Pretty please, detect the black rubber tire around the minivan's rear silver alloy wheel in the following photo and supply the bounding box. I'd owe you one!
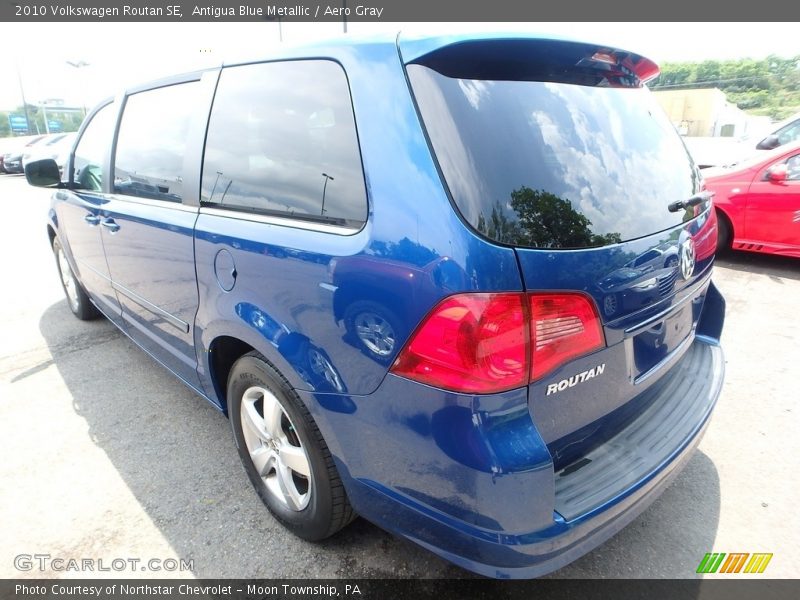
[227,352,356,542]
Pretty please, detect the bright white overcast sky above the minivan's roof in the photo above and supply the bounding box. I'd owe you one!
[0,22,800,110]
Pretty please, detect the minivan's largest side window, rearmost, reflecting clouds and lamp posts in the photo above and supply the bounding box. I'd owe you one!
[202,60,367,228]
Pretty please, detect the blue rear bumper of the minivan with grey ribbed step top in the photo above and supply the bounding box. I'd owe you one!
[302,336,724,578]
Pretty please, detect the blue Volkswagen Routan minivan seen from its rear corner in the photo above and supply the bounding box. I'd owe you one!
[26,35,725,577]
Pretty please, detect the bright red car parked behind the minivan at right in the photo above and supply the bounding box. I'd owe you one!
[704,142,800,258]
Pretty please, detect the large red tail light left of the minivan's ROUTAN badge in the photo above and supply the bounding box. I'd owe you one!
[391,293,604,394]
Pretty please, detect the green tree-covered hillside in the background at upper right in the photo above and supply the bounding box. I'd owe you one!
[650,54,800,120]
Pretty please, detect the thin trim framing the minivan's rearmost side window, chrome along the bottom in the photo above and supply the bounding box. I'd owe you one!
[197,56,371,236]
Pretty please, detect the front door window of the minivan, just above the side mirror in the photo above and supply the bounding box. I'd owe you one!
[72,103,117,192]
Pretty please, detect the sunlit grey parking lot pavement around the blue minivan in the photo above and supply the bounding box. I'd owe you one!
[0,175,800,578]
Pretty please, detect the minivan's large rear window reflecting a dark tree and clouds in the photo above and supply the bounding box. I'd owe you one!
[408,64,700,248]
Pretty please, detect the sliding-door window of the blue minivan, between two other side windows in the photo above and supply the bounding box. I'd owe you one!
[114,82,198,202]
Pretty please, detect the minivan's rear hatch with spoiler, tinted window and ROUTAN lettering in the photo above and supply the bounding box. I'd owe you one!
[401,39,716,470]
